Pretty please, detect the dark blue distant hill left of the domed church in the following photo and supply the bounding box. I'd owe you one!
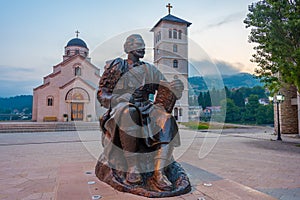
[0,95,32,113]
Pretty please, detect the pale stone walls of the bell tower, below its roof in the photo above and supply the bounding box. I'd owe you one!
[153,21,189,122]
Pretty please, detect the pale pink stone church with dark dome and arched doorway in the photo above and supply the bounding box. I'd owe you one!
[32,31,100,122]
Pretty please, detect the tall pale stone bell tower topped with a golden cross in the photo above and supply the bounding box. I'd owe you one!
[151,4,192,122]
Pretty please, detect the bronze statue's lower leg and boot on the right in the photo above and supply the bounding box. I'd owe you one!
[153,146,173,191]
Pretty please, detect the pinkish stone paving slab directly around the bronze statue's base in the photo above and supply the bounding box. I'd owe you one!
[55,163,275,200]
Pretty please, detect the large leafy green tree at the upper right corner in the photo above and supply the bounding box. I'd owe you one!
[244,0,300,93]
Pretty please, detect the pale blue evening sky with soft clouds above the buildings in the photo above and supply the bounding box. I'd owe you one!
[0,0,255,97]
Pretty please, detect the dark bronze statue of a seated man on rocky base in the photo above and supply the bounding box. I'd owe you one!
[95,34,191,197]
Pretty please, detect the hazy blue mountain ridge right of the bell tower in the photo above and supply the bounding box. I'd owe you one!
[189,73,263,92]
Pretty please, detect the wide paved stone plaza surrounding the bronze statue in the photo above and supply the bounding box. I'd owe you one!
[0,124,300,200]
